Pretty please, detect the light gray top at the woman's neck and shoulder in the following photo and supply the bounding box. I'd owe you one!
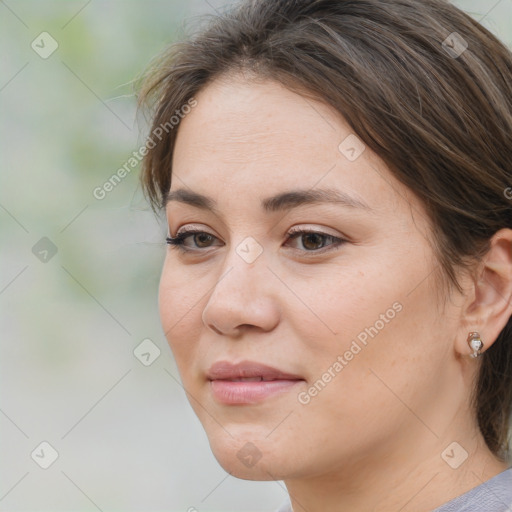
[276,467,512,512]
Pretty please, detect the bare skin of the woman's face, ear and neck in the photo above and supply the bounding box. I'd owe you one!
[159,75,512,512]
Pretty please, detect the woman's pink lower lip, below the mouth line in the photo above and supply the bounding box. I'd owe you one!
[210,380,304,405]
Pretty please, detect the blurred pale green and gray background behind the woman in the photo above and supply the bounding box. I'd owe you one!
[0,0,512,512]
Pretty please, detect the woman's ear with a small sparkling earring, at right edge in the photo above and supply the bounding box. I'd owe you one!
[457,228,512,355]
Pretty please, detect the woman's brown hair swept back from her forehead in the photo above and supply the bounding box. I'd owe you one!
[139,0,512,460]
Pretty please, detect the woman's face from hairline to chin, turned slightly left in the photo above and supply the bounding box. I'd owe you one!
[159,77,463,480]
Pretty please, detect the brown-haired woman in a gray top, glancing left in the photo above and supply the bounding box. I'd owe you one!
[140,0,512,512]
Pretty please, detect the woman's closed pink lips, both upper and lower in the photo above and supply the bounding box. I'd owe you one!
[207,361,305,405]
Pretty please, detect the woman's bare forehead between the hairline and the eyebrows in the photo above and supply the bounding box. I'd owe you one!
[171,76,413,215]
